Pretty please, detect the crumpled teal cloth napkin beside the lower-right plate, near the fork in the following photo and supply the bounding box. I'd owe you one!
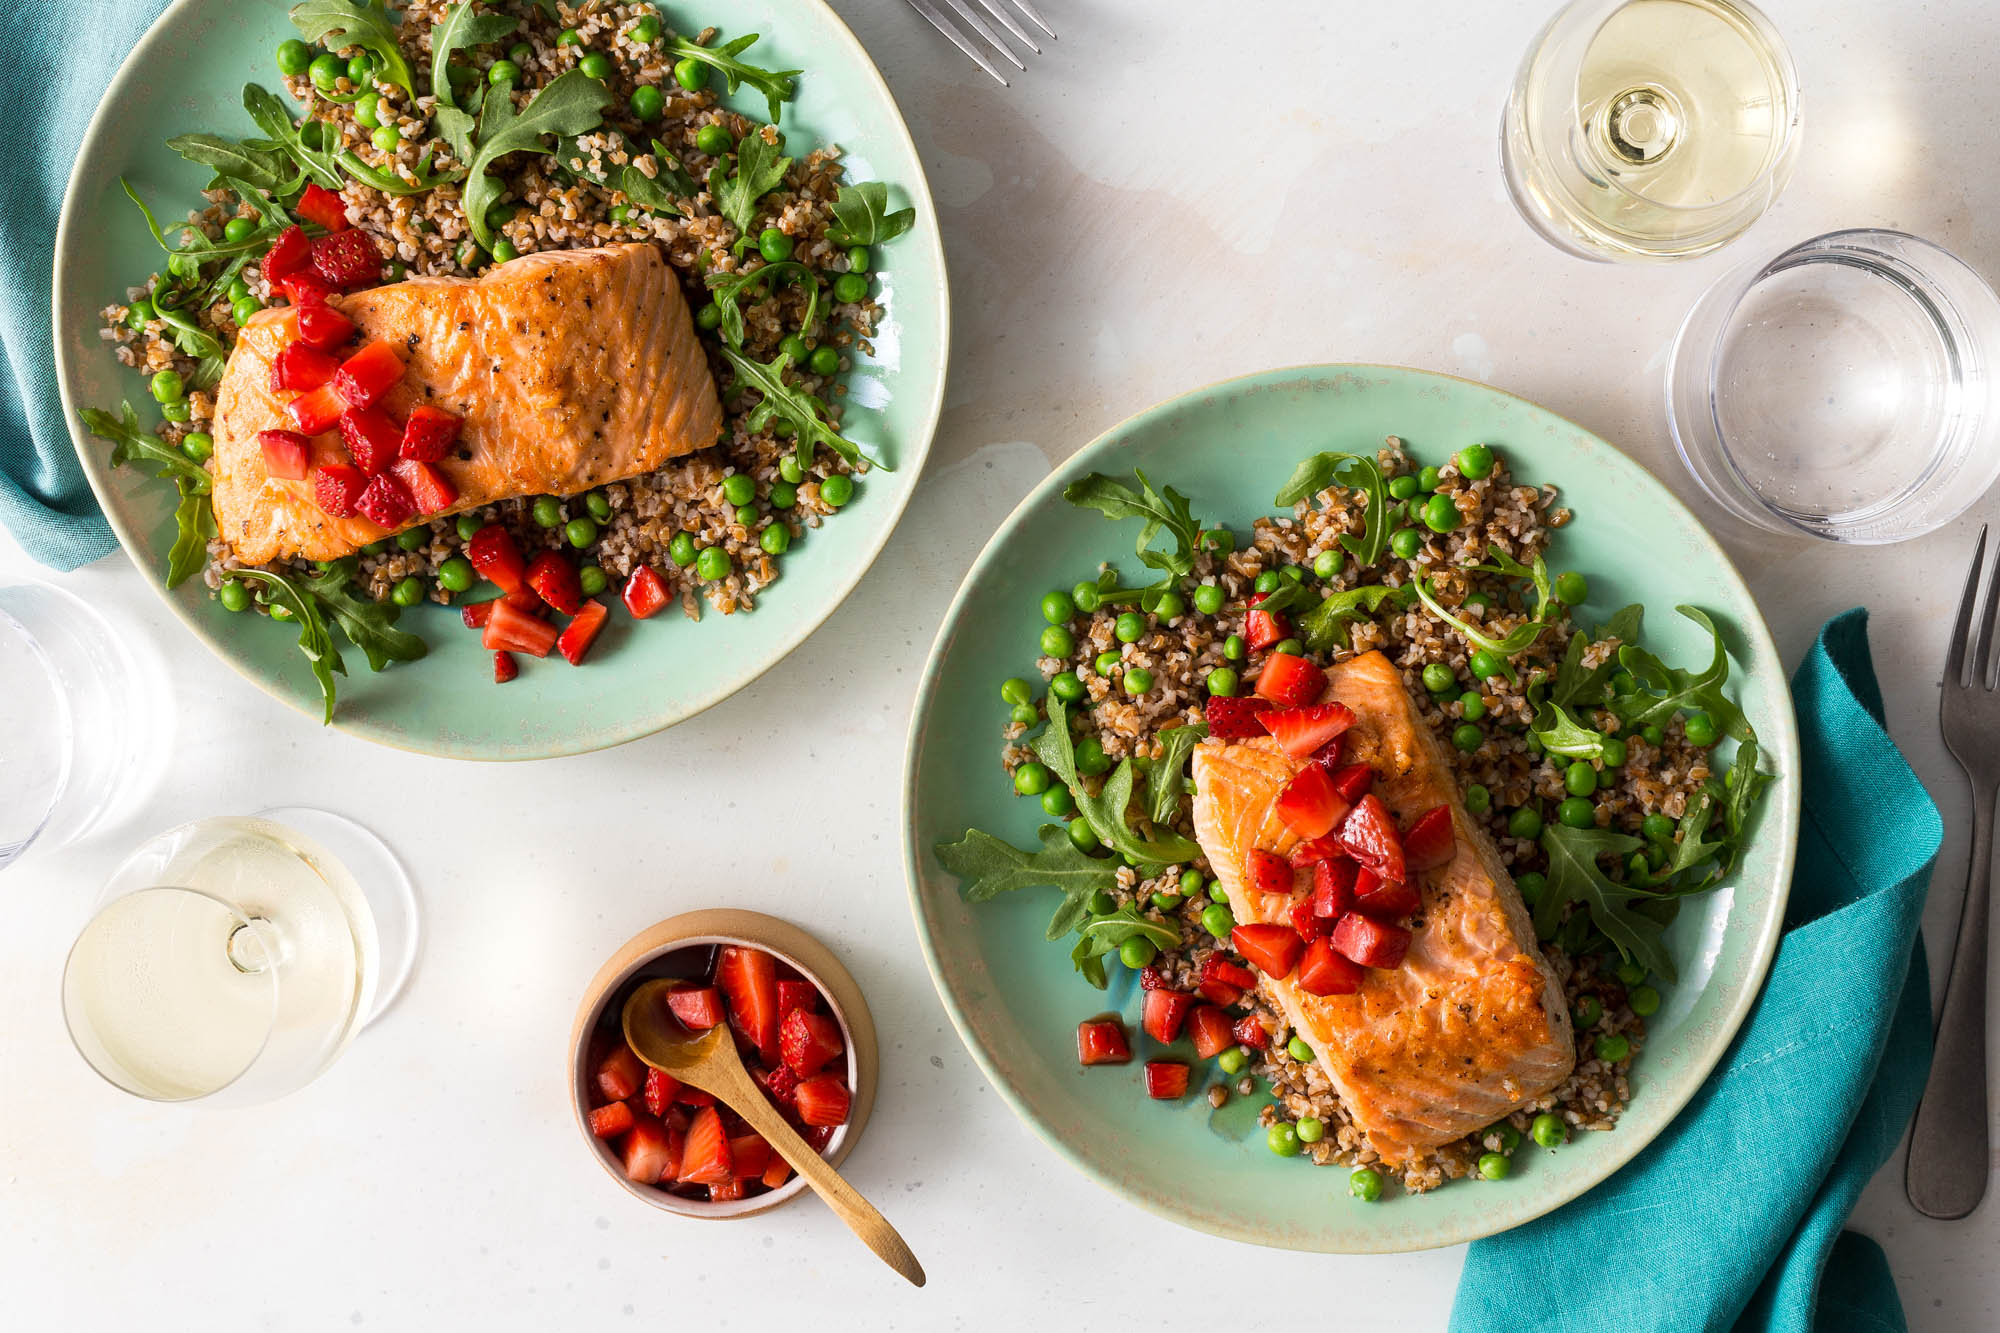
[1452,610,1942,1333]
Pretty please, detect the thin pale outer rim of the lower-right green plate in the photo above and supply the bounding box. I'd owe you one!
[902,362,1800,1255]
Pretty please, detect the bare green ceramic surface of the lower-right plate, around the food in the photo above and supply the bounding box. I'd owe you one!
[904,366,1798,1253]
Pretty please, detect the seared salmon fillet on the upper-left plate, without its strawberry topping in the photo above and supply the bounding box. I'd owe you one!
[214,244,722,564]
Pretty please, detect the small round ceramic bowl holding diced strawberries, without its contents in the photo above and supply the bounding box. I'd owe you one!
[570,909,880,1219]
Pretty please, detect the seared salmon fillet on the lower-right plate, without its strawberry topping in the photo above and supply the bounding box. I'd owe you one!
[1194,652,1576,1165]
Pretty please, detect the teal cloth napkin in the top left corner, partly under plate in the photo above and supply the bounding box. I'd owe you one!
[0,0,164,568]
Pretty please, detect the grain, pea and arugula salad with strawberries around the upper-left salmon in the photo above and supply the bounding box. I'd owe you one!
[82,0,914,719]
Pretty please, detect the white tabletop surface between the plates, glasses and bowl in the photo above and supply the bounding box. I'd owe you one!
[0,0,2000,1329]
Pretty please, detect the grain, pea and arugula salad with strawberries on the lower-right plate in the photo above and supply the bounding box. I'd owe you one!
[936,436,1770,1201]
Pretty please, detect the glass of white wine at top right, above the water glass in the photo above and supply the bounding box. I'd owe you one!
[1500,0,1800,260]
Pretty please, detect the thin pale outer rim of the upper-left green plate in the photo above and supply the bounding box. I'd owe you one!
[50,0,952,763]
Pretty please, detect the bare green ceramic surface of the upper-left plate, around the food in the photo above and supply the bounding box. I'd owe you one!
[56,0,950,759]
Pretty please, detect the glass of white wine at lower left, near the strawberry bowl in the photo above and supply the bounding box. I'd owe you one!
[62,809,416,1105]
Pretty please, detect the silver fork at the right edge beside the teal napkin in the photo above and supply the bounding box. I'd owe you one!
[1902,526,2000,1221]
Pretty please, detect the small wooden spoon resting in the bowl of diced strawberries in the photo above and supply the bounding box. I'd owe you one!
[624,979,924,1287]
